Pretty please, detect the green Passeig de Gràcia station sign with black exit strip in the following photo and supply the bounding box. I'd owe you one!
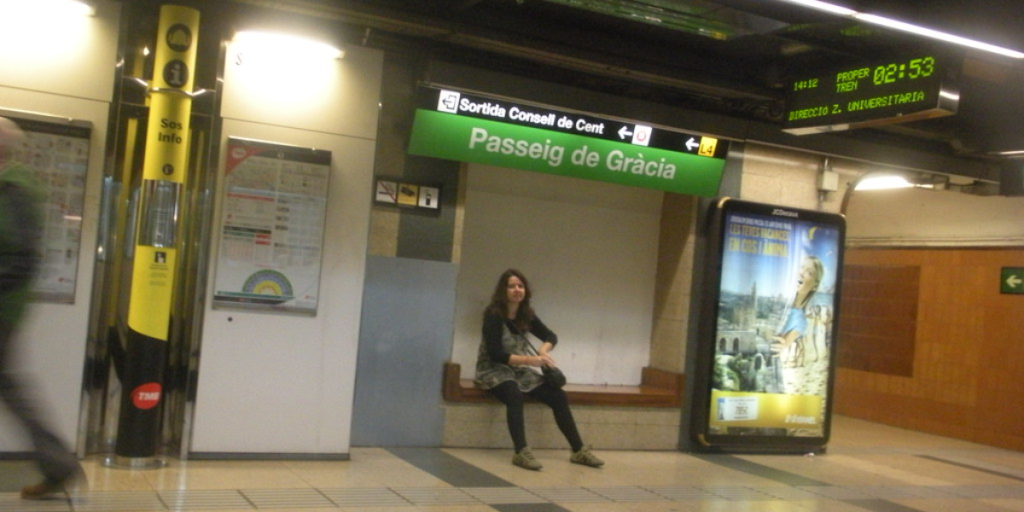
[409,89,727,197]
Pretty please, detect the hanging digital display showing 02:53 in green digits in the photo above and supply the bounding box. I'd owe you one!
[782,54,959,135]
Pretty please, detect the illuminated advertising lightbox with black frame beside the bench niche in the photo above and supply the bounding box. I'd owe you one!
[693,199,845,450]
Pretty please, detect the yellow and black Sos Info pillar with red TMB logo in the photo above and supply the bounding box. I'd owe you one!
[115,5,199,467]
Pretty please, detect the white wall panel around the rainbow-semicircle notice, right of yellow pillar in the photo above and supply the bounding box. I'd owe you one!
[190,41,383,455]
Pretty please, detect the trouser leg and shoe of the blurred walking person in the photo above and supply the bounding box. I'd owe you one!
[0,322,81,496]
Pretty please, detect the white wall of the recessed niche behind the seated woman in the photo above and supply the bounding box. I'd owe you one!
[453,164,662,385]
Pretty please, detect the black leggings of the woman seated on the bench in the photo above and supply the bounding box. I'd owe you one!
[490,381,583,454]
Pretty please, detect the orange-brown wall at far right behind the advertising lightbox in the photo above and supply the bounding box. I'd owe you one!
[834,248,1024,451]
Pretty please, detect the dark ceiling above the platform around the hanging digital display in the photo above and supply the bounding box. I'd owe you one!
[228,0,1024,181]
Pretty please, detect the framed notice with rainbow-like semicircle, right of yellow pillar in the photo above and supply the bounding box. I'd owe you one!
[214,137,331,314]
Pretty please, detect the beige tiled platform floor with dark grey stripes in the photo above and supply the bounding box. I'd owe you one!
[0,417,1024,512]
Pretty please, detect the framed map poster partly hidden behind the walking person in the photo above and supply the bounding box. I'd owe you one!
[0,110,92,304]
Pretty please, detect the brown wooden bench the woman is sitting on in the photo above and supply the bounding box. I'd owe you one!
[442,361,683,408]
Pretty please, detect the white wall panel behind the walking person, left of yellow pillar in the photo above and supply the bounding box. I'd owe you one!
[0,0,120,452]
